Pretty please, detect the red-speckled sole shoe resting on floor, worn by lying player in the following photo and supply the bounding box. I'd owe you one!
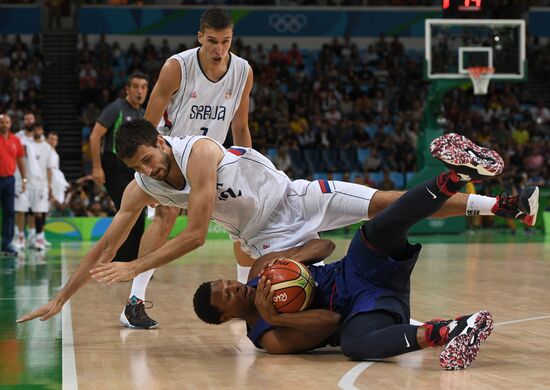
[423,310,493,370]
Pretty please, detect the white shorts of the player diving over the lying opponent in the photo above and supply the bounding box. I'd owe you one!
[240,180,377,258]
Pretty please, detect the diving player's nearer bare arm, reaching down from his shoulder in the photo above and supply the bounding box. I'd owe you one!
[91,139,223,284]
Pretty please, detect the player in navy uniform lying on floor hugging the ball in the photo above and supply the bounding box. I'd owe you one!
[193,134,504,370]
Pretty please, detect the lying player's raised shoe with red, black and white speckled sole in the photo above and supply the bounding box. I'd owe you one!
[430,133,504,181]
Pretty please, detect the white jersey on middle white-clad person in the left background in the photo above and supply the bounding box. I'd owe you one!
[26,141,54,189]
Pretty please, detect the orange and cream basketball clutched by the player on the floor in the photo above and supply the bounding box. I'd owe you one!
[263,259,315,313]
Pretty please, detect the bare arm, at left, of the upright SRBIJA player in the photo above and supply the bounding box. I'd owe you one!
[144,59,181,127]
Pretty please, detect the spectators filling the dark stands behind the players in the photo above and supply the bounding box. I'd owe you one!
[0,32,550,225]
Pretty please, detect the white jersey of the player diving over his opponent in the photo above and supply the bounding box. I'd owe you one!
[135,136,290,241]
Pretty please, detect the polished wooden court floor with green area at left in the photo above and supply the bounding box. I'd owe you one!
[0,236,550,390]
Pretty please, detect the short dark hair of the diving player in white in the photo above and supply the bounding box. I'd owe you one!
[115,119,159,160]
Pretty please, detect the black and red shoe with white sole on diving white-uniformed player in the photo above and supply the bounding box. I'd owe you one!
[491,186,539,226]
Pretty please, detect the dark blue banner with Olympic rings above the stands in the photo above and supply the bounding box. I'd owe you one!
[79,6,441,37]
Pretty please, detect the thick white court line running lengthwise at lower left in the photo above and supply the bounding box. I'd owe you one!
[61,242,78,390]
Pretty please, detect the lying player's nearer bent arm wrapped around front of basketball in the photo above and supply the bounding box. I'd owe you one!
[254,277,341,354]
